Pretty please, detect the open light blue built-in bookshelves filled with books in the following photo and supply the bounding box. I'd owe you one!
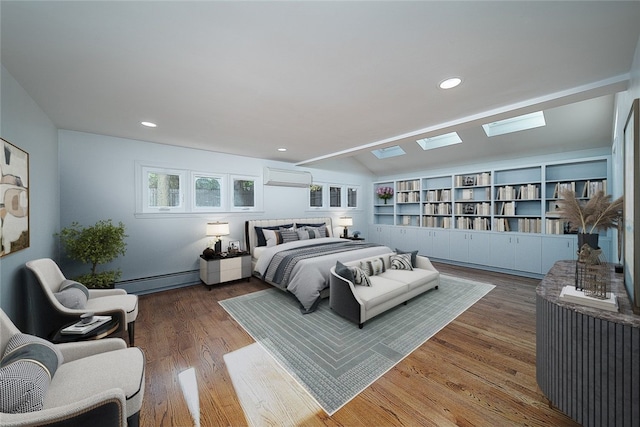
[373,157,608,234]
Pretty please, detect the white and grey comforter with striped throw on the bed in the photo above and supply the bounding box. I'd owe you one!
[255,237,391,313]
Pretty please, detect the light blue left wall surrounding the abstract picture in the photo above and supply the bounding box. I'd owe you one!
[0,67,60,331]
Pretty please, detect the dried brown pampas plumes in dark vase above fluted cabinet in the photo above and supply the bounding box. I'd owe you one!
[559,190,623,249]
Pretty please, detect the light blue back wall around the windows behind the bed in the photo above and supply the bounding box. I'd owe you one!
[58,130,371,293]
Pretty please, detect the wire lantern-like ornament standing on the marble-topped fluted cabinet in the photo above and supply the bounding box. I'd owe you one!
[575,243,609,299]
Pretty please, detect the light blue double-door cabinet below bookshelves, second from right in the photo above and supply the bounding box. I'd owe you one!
[489,233,542,274]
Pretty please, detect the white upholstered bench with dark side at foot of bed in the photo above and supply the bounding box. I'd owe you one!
[329,254,440,328]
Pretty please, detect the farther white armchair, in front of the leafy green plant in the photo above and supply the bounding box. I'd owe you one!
[26,258,138,345]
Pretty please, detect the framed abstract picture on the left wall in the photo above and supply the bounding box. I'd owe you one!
[0,138,29,257]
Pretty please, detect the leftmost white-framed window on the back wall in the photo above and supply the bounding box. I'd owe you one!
[142,167,185,212]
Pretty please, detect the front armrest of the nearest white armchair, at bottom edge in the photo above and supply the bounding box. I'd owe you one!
[0,388,127,427]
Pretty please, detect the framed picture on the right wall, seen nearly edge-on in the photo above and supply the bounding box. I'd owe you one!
[623,99,640,314]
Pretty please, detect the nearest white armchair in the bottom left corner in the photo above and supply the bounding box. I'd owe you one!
[0,310,145,427]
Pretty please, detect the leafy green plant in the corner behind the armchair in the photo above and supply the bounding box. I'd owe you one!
[58,219,129,288]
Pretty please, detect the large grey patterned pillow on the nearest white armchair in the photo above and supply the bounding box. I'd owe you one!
[0,334,63,414]
